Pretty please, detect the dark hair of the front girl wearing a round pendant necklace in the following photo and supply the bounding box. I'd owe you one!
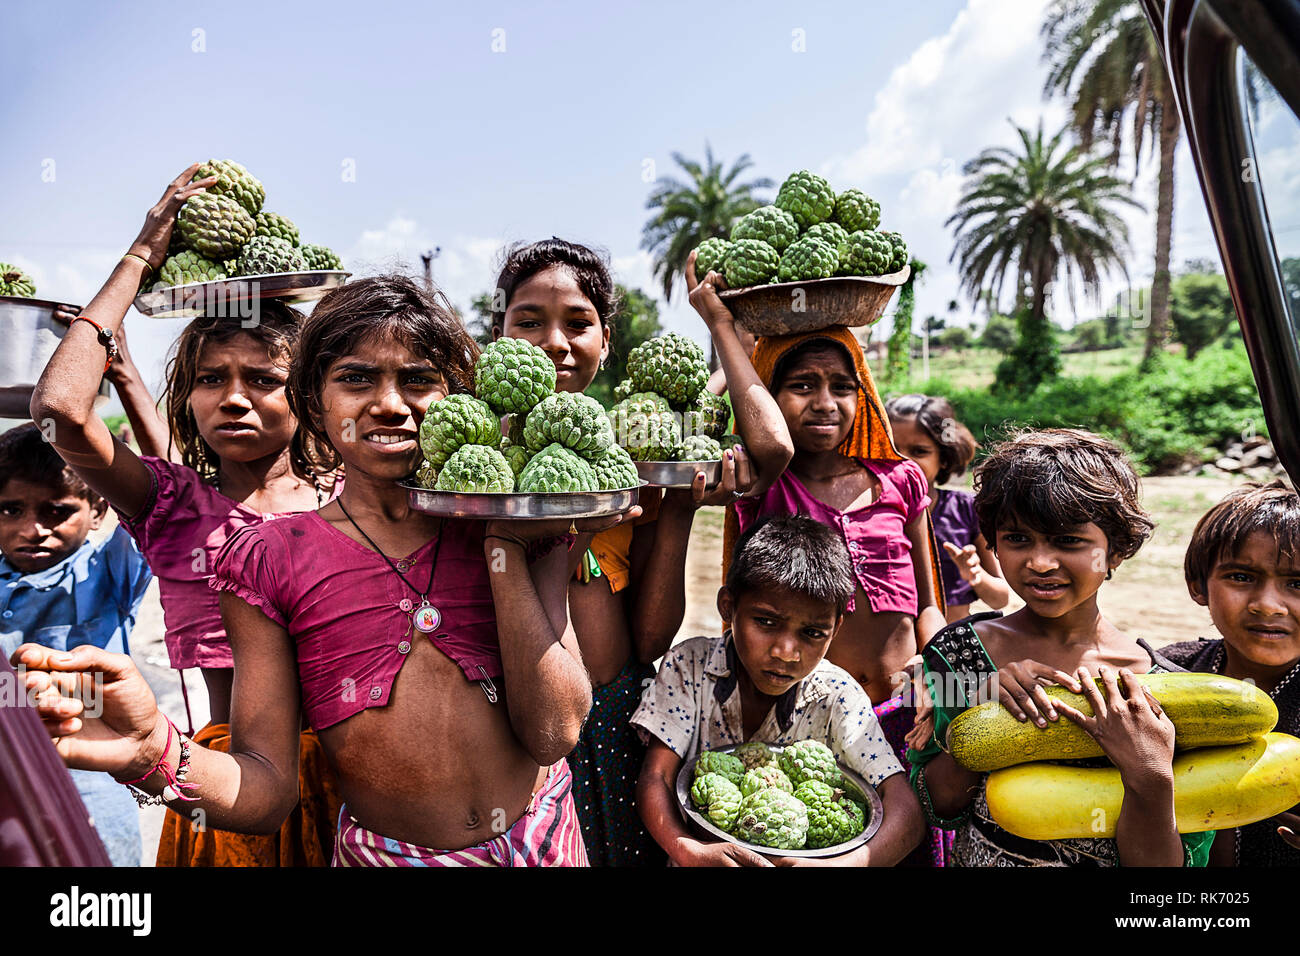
[285,276,478,479]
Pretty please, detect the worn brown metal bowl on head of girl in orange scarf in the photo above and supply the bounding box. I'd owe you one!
[718,265,911,336]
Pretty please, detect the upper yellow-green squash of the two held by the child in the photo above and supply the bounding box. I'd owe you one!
[948,674,1278,773]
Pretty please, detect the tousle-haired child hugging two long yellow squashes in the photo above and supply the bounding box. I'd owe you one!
[909,429,1213,866]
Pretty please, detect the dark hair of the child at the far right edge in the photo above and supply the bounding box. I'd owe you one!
[1183,479,1300,591]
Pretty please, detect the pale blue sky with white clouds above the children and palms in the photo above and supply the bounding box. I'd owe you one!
[0,0,1289,407]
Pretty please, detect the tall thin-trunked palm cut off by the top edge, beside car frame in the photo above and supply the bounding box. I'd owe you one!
[1043,0,1182,362]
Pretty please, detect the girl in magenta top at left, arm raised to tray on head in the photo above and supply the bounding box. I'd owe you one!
[31,165,338,866]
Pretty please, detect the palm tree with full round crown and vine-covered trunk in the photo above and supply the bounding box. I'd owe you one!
[946,121,1141,389]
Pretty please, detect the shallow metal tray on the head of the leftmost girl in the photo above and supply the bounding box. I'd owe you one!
[135,269,352,319]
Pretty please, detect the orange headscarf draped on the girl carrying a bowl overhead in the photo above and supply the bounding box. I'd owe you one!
[723,325,944,610]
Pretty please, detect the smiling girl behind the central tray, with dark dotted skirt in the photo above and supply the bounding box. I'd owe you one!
[493,238,749,866]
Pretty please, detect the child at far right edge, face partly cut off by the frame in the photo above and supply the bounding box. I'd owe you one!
[1160,481,1300,866]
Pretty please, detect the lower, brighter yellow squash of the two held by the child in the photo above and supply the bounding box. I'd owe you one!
[984,734,1300,840]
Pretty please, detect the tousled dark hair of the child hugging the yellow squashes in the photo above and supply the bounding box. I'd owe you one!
[975,428,1156,558]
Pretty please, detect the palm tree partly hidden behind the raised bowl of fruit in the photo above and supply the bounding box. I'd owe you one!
[641,143,775,302]
